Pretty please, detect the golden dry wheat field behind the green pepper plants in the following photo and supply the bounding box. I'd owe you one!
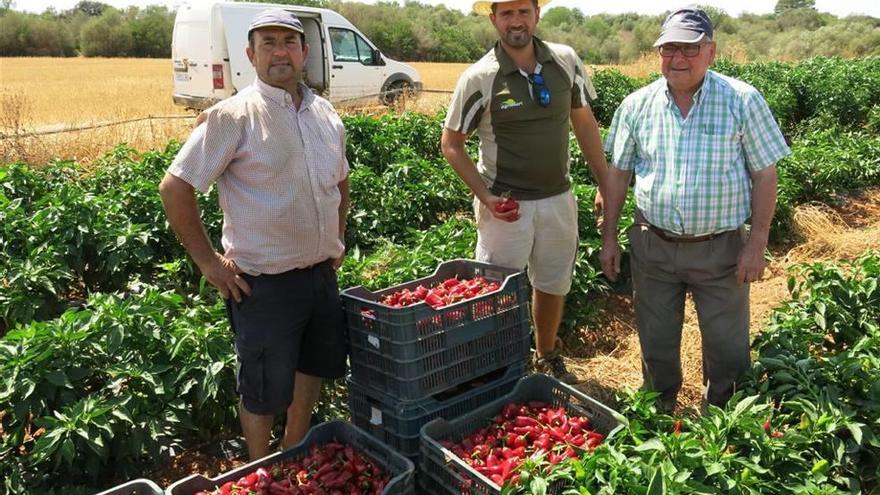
[0,57,654,164]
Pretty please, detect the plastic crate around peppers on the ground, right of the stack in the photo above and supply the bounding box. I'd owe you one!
[419,375,622,495]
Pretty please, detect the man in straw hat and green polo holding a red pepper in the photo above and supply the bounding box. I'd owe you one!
[442,0,607,383]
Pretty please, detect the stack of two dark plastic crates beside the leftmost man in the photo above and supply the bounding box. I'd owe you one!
[342,260,531,461]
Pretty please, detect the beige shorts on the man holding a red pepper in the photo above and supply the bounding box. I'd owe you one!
[474,191,578,296]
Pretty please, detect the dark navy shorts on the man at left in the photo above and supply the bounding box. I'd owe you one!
[226,260,348,415]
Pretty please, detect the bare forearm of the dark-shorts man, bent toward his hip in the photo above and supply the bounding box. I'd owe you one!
[159,174,215,267]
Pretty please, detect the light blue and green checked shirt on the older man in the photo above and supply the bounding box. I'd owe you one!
[605,71,791,235]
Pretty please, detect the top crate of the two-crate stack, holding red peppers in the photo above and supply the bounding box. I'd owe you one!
[342,260,531,400]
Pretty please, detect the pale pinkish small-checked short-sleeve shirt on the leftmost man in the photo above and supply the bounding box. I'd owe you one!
[168,78,349,275]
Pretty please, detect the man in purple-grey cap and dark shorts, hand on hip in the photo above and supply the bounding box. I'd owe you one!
[159,8,349,459]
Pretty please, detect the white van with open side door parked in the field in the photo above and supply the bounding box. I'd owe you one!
[171,1,422,110]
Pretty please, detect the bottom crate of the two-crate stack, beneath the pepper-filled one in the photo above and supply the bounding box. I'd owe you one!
[348,362,525,459]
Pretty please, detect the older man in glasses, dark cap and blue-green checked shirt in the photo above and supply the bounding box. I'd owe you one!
[600,8,790,409]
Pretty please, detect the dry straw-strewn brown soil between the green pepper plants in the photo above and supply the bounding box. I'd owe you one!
[151,188,880,486]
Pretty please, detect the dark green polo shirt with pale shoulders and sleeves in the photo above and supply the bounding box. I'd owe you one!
[445,38,596,200]
